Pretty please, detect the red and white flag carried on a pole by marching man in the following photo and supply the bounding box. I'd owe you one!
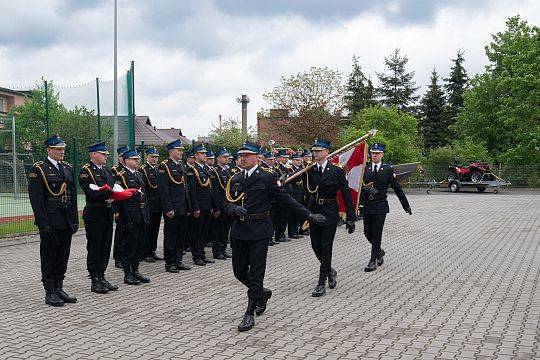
[332,142,367,212]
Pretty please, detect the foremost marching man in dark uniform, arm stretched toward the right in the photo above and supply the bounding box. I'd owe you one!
[223,142,325,331]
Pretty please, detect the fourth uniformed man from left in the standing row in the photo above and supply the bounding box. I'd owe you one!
[139,147,163,262]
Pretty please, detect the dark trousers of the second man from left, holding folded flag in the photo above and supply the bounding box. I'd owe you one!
[84,220,113,277]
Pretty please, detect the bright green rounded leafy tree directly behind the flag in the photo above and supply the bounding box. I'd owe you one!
[340,105,420,164]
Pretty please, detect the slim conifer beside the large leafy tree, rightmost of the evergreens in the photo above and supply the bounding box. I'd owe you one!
[444,51,469,124]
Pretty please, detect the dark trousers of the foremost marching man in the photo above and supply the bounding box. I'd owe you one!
[231,239,270,300]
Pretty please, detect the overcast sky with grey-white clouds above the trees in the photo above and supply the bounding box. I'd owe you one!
[0,0,540,137]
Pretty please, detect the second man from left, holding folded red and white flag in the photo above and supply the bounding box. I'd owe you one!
[79,142,118,294]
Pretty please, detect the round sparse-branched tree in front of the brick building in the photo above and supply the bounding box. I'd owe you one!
[262,67,344,144]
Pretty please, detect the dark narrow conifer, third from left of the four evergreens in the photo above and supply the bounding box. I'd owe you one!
[419,68,449,149]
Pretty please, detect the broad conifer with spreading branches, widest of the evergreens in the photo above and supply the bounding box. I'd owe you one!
[377,49,419,113]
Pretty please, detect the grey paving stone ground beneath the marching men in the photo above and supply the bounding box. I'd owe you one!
[0,192,540,359]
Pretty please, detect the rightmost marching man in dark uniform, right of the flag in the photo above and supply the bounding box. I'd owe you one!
[361,144,412,272]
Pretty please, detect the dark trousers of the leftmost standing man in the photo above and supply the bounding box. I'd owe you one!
[39,229,72,291]
